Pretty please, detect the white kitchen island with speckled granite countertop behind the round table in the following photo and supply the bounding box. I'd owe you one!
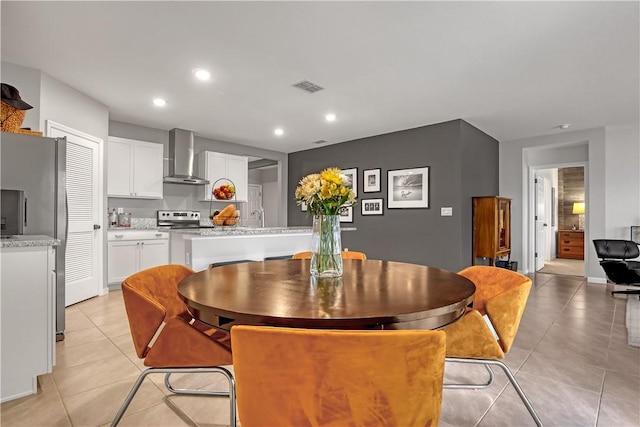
[170,227,311,271]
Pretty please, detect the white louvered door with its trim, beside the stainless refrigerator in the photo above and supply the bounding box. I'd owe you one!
[47,121,104,307]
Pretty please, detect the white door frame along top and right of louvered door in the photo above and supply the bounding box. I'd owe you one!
[45,120,109,296]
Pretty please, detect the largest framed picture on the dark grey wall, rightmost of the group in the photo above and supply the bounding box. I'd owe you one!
[387,166,429,209]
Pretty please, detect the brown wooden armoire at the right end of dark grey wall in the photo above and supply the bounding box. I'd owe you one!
[472,196,511,265]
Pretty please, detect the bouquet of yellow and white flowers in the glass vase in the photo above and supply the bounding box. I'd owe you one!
[296,168,356,215]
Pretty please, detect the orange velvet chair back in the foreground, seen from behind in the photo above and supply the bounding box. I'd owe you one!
[231,325,445,427]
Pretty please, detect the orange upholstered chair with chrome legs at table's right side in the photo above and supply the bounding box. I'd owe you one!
[443,266,542,425]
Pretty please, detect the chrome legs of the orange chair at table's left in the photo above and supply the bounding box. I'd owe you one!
[111,366,237,427]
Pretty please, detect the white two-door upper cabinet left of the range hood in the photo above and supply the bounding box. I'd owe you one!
[107,136,163,199]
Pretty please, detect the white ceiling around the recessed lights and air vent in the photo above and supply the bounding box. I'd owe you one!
[1,1,640,152]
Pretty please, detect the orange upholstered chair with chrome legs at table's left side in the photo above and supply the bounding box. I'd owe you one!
[111,265,236,426]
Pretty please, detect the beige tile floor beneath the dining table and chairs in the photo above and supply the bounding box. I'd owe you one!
[0,274,640,427]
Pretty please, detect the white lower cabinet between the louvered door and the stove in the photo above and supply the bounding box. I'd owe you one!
[107,230,169,284]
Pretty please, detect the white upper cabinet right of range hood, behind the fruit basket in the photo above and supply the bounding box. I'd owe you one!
[198,151,249,202]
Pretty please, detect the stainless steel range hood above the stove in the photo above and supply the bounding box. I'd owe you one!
[164,129,209,185]
